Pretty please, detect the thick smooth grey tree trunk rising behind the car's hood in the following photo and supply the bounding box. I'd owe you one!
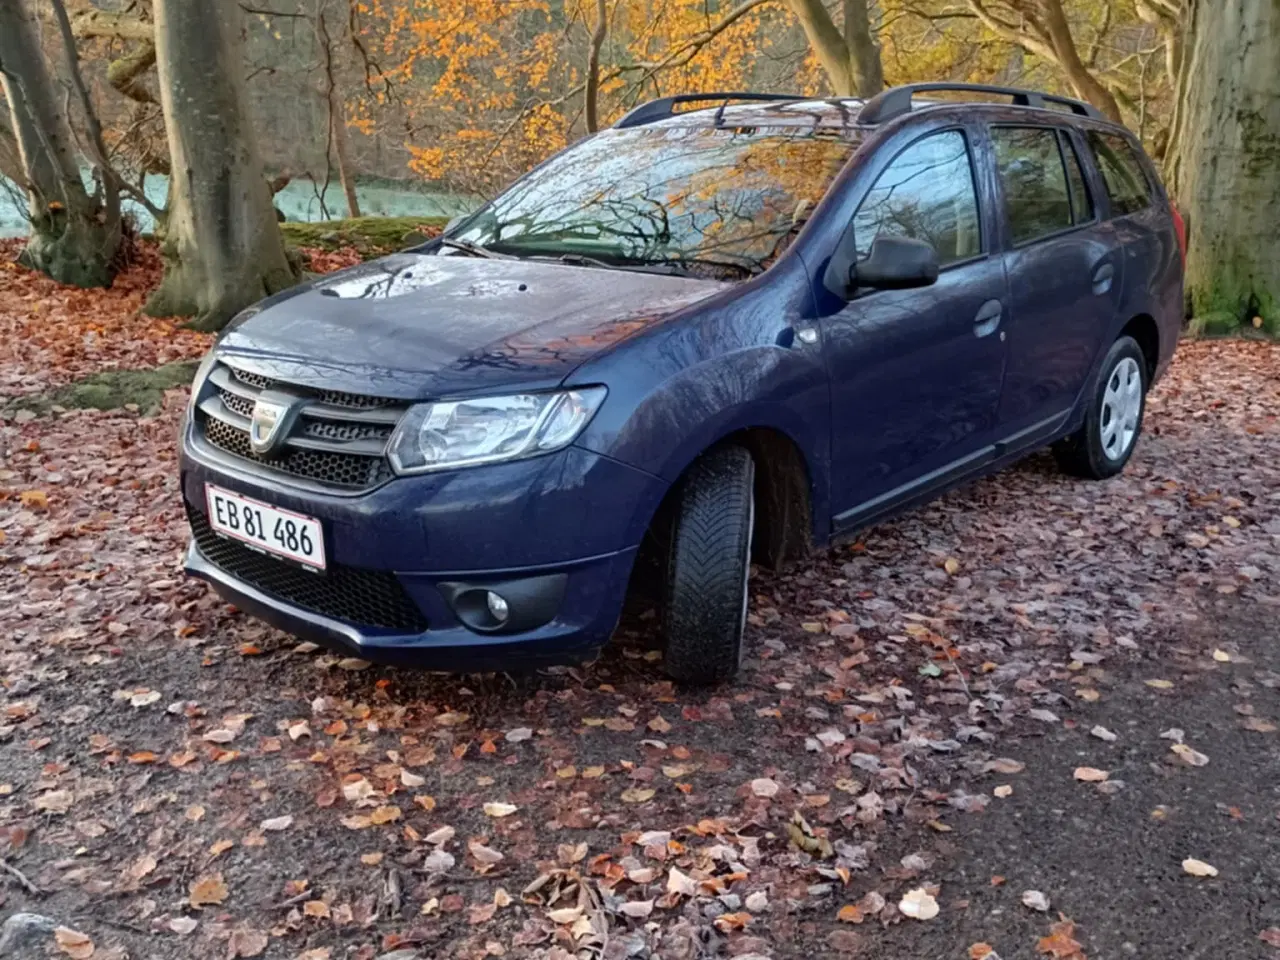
[144,0,298,330]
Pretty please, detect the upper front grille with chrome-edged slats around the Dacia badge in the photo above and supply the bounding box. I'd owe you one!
[196,364,404,490]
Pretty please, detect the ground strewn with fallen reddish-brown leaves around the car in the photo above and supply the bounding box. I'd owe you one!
[0,255,1280,960]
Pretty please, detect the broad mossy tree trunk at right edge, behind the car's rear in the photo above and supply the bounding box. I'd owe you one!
[1172,0,1280,334]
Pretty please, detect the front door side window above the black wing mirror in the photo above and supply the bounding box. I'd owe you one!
[854,131,982,266]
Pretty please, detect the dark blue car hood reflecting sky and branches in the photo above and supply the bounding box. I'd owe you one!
[218,253,731,399]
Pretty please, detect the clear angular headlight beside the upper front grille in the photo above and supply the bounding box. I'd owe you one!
[390,387,607,474]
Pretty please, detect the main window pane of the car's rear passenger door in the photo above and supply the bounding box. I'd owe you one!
[991,127,1071,244]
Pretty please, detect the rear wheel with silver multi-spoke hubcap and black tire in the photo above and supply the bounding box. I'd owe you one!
[1053,337,1148,480]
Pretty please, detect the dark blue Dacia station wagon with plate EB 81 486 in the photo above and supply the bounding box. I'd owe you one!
[182,84,1183,682]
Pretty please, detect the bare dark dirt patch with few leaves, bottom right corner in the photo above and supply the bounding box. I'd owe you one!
[869,600,1280,960]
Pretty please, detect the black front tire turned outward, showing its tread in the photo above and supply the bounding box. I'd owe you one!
[663,447,755,684]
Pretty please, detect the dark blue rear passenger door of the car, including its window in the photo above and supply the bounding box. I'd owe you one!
[989,125,1124,445]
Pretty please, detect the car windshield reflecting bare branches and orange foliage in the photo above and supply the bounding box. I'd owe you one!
[453,127,856,275]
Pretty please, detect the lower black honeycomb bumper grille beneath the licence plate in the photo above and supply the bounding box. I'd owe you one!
[187,503,426,634]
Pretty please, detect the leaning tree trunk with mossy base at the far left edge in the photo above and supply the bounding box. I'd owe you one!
[0,0,120,287]
